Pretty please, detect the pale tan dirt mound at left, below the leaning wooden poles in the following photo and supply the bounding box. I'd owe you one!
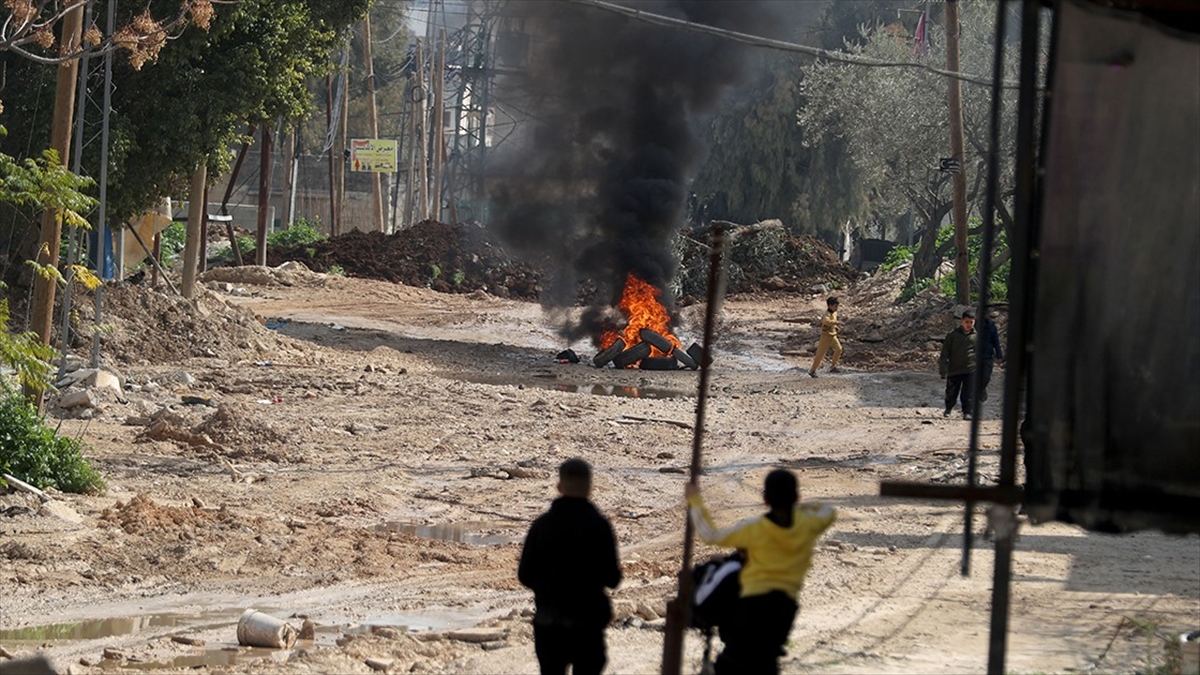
[71,283,299,365]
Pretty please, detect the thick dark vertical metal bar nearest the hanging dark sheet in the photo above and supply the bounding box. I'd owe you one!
[988,0,1046,675]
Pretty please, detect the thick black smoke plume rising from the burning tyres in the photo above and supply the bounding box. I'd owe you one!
[488,0,779,340]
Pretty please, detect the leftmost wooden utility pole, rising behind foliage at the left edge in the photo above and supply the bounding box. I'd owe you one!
[25,1,85,410]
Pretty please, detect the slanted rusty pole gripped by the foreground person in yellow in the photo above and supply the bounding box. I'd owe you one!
[662,221,732,675]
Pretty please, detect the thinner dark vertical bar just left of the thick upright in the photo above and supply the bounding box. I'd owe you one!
[961,0,1008,577]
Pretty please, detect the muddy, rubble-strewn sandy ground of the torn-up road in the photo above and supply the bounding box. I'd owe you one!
[0,268,1200,675]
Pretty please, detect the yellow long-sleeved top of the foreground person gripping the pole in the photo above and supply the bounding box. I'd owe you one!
[688,494,838,599]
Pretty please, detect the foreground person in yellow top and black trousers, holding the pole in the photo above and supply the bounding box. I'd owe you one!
[684,468,836,675]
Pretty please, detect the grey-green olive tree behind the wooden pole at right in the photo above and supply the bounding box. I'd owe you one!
[799,1,1032,289]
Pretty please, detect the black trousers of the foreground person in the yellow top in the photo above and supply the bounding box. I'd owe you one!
[713,591,799,675]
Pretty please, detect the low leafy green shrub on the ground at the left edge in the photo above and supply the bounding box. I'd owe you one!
[0,395,104,492]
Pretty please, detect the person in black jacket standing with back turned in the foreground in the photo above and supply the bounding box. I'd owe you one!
[517,459,620,675]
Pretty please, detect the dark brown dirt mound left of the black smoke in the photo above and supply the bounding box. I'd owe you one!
[266,220,540,300]
